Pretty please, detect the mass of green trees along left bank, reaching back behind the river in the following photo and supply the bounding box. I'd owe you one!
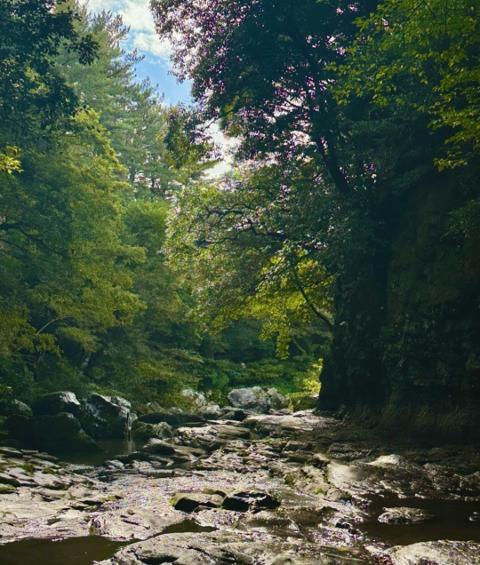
[0,1,326,403]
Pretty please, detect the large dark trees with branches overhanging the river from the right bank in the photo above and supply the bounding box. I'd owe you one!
[152,0,480,418]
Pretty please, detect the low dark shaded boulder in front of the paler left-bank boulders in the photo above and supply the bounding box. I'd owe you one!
[33,412,100,453]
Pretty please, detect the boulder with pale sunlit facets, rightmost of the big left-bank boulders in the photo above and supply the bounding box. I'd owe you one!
[81,393,136,439]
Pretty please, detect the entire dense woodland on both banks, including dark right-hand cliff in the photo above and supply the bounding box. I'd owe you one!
[0,0,480,431]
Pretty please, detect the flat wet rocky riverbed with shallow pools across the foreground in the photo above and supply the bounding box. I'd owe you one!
[0,410,480,565]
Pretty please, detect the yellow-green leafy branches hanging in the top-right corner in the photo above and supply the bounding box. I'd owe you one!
[341,0,480,170]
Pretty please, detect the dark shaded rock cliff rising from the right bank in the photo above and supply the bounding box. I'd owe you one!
[319,173,480,434]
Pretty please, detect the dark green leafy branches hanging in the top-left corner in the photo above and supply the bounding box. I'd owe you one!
[0,0,96,147]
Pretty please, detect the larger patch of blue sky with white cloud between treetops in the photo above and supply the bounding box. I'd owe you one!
[84,0,191,104]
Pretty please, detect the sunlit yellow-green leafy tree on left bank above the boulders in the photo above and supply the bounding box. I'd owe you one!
[0,111,143,396]
